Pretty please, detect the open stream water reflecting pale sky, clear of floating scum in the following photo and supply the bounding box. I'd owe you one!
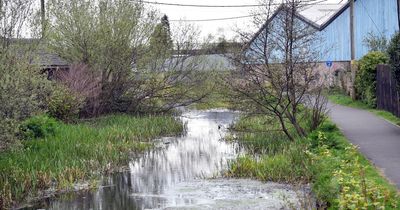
[29,110,241,209]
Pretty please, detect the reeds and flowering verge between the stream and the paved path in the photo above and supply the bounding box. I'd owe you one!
[227,117,400,209]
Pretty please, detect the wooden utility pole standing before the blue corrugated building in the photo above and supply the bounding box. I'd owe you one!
[349,0,357,100]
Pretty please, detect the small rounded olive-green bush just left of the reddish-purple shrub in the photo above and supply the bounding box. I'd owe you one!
[49,85,85,122]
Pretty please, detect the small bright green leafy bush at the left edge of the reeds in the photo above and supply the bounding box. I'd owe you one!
[19,115,57,140]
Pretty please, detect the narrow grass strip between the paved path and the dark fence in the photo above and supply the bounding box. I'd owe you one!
[328,91,400,126]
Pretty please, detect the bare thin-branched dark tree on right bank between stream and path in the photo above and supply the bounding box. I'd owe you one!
[227,0,326,140]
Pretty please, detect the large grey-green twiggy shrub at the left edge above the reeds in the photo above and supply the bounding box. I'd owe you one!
[0,49,52,150]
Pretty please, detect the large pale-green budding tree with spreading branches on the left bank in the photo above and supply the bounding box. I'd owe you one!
[48,0,209,114]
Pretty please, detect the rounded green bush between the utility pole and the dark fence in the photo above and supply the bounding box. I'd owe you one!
[355,52,388,108]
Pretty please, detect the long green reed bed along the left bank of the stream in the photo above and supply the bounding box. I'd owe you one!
[0,115,183,209]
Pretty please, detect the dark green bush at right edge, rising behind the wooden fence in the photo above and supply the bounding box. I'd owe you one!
[388,33,400,90]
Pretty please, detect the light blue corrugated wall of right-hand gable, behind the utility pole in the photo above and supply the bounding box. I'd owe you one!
[320,0,399,61]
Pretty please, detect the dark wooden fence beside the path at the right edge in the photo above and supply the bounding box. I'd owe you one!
[376,65,400,117]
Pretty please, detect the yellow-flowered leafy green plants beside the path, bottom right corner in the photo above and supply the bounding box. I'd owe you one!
[309,121,400,209]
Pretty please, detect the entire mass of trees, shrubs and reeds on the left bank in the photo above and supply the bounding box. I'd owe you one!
[0,0,203,209]
